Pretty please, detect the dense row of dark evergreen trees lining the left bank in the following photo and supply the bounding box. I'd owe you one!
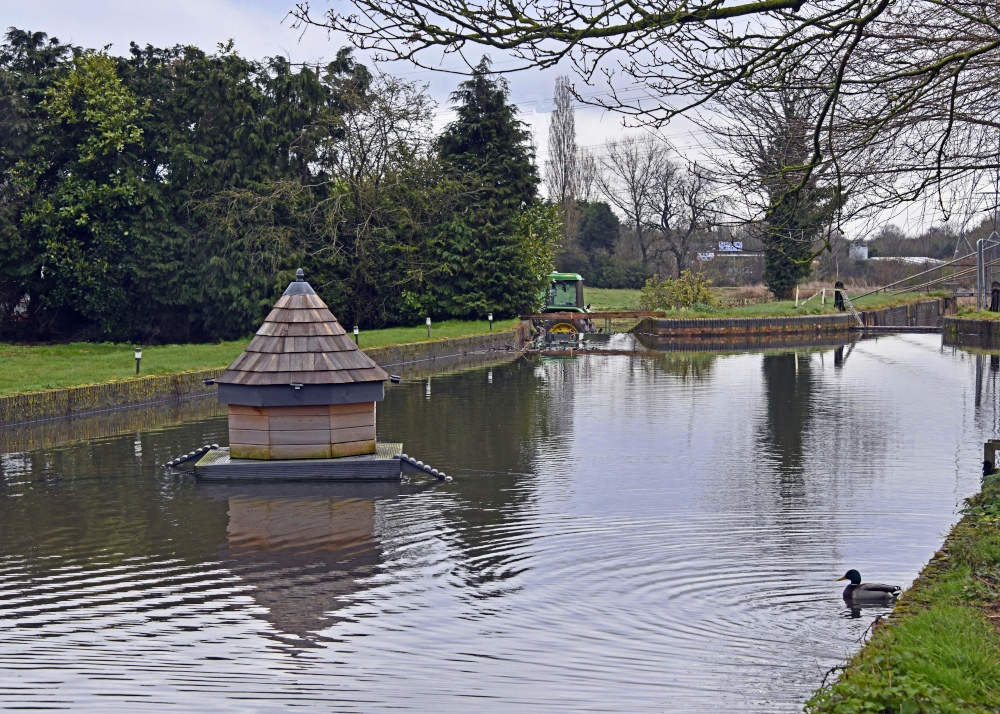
[0,29,559,342]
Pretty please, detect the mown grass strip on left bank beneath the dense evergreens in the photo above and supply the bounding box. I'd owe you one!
[0,320,517,394]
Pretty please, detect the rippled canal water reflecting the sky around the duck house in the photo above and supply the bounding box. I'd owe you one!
[0,335,1000,712]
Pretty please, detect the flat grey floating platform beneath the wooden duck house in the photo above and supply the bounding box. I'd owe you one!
[194,443,450,481]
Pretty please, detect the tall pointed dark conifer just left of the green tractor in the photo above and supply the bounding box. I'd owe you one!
[422,58,559,318]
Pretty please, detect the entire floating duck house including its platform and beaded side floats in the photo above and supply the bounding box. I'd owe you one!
[183,269,448,481]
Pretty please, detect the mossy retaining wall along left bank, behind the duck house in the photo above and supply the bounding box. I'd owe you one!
[0,324,529,427]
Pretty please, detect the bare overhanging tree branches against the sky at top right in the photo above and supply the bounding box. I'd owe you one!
[292,0,1000,211]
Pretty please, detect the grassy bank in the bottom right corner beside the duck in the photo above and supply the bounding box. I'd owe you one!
[806,474,1000,714]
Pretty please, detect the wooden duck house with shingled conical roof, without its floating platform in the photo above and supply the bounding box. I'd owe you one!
[215,269,389,460]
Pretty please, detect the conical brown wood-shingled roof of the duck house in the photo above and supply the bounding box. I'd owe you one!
[215,272,389,386]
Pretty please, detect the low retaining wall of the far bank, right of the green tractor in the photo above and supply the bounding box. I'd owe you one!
[633,298,955,338]
